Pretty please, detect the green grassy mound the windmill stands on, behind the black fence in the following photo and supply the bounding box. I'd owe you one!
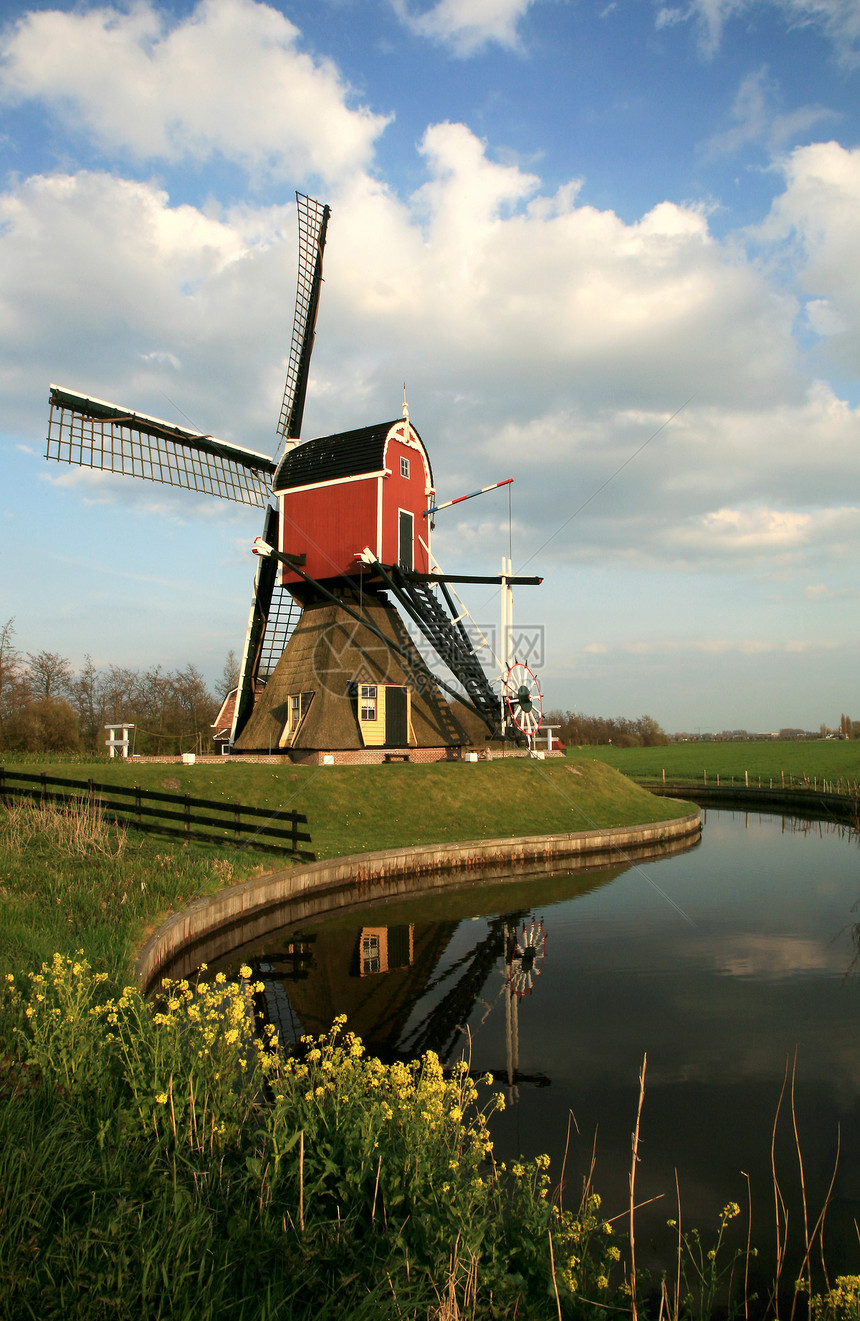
[0,757,679,865]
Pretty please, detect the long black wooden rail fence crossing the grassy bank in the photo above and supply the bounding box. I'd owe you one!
[0,766,316,861]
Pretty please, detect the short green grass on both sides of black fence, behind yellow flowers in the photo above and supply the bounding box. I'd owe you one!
[0,758,687,982]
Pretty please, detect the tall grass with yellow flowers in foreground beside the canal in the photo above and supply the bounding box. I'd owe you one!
[0,954,860,1321]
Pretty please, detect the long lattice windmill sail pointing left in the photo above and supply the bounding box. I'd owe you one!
[45,386,275,509]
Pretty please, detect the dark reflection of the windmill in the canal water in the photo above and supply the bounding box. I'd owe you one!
[235,868,620,1087]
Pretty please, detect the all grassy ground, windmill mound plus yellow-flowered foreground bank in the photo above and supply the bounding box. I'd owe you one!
[0,758,860,1321]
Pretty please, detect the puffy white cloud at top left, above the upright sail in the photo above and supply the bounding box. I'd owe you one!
[0,0,388,181]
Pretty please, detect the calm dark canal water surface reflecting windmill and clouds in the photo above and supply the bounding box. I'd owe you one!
[210,811,860,1289]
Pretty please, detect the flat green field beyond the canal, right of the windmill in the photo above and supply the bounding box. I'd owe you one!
[568,738,860,787]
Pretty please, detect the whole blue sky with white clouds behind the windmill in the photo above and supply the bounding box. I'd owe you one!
[0,0,860,733]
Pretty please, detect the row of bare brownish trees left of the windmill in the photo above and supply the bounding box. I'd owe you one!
[0,620,238,757]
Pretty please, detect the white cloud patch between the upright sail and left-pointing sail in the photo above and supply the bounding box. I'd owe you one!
[0,172,306,448]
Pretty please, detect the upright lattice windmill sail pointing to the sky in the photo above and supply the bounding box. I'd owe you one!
[277,193,332,453]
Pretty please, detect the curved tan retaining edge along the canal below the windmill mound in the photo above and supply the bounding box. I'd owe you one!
[136,811,701,989]
